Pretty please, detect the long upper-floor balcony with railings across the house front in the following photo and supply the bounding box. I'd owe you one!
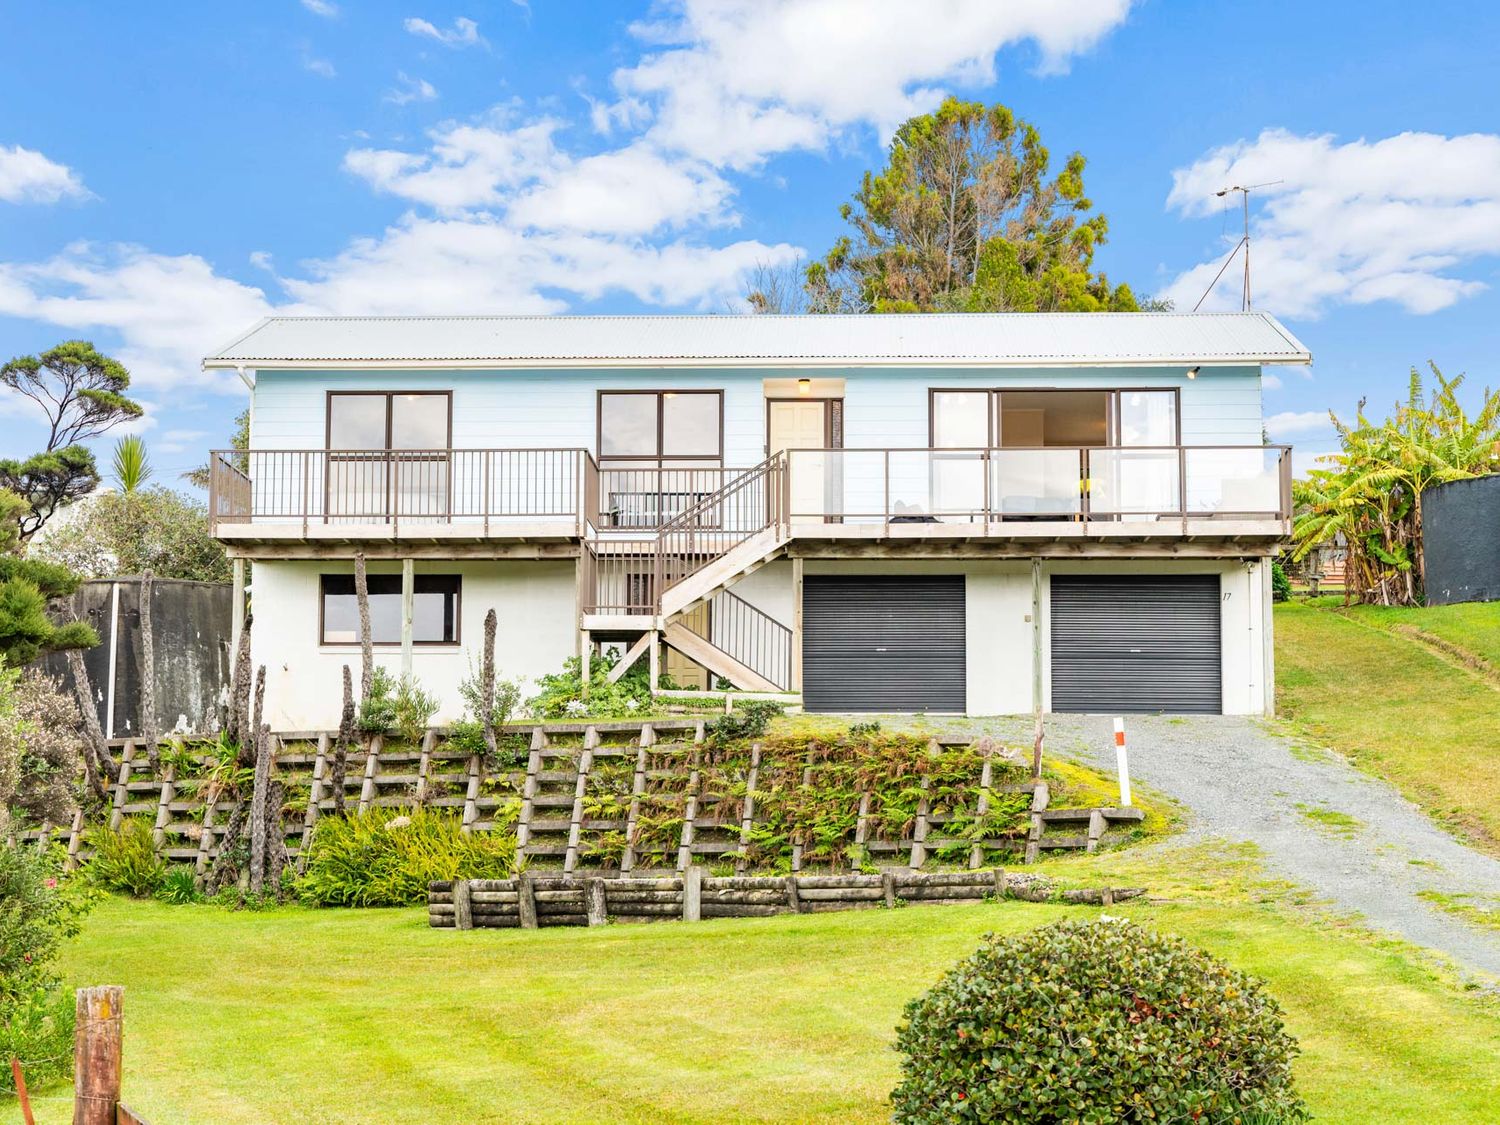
[209,446,1292,558]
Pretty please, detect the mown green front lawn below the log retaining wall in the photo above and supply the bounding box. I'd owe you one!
[39,846,1500,1125]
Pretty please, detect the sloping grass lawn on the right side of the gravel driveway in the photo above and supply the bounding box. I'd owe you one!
[1277,602,1500,855]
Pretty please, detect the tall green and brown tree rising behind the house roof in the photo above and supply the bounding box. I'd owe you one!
[780,98,1140,312]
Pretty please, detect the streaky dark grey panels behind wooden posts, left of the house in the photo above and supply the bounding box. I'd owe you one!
[42,578,234,738]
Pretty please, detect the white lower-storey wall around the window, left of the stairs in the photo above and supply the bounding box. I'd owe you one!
[251,561,578,731]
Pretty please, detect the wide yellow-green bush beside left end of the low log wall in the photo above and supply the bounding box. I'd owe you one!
[297,810,516,906]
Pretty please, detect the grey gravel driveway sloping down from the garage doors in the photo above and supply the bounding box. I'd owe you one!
[984,716,1500,977]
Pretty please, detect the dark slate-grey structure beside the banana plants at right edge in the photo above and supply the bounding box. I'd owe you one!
[1422,474,1500,606]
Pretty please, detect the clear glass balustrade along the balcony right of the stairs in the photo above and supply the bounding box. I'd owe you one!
[786,446,1292,525]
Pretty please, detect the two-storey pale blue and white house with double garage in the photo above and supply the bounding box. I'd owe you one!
[204,314,1311,731]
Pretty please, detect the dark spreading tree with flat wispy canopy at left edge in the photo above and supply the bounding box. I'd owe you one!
[0,341,144,540]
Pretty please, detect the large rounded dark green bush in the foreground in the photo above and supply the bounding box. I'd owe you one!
[891,920,1308,1125]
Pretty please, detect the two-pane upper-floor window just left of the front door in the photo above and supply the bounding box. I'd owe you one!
[599,390,725,468]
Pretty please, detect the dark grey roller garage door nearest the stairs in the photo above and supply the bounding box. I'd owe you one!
[803,575,966,713]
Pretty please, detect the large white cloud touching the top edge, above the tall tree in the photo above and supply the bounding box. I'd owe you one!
[605,0,1131,168]
